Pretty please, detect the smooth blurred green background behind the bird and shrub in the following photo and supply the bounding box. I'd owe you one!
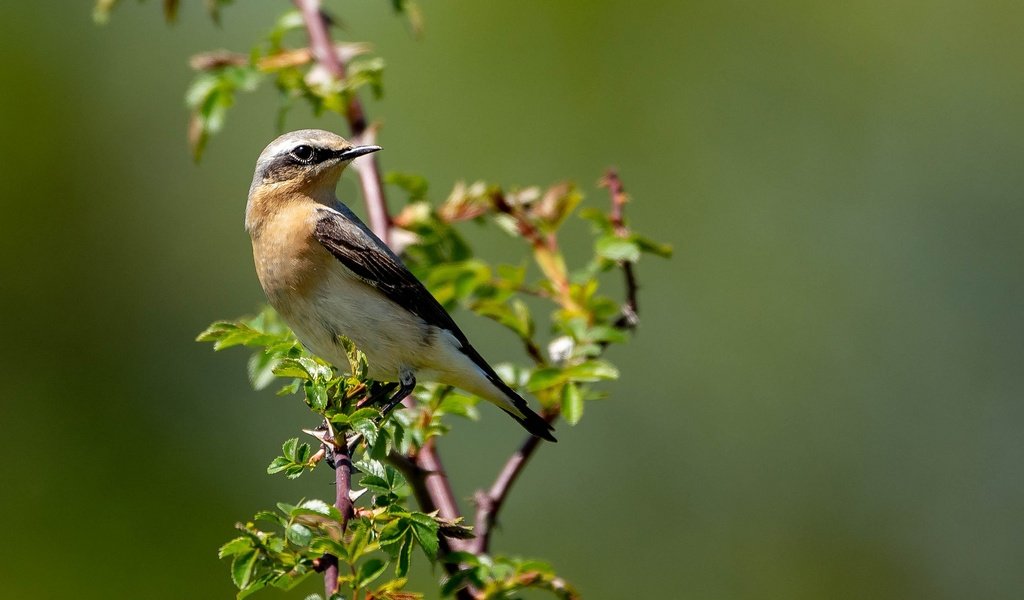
[0,0,1024,599]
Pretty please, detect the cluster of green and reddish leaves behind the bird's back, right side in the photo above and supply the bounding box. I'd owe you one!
[386,174,672,425]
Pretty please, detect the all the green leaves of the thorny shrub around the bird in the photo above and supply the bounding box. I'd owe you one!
[94,0,671,600]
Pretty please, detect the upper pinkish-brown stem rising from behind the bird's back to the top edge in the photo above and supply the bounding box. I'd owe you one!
[294,0,391,245]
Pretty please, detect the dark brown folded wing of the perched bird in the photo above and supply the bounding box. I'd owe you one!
[313,209,471,346]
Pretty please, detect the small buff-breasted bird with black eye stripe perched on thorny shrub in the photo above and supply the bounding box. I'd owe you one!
[245,129,556,441]
